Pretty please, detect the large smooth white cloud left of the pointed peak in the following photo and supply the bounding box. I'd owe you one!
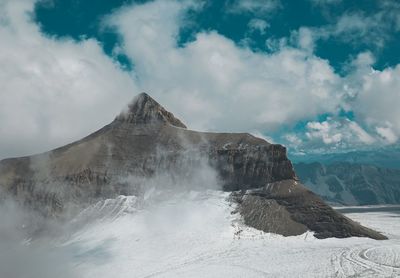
[0,0,137,158]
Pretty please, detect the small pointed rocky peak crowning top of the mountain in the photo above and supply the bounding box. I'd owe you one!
[116,93,186,128]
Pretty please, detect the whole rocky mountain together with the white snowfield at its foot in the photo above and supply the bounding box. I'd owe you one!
[0,94,400,278]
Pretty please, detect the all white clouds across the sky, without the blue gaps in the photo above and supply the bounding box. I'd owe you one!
[0,0,400,158]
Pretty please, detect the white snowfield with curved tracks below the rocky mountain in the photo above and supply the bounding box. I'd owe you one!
[57,191,400,278]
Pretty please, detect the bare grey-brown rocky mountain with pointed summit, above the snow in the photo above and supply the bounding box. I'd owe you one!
[0,93,385,239]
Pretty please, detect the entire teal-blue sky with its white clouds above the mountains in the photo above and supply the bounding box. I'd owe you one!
[0,0,400,159]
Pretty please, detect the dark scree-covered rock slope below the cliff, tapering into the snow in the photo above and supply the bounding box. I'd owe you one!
[236,180,386,239]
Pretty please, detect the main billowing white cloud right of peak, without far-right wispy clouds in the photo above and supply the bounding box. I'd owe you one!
[108,1,341,131]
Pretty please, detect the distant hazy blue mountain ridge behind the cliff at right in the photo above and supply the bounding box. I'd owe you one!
[295,162,400,205]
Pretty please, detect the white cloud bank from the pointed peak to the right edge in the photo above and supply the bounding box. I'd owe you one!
[106,1,400,149]
